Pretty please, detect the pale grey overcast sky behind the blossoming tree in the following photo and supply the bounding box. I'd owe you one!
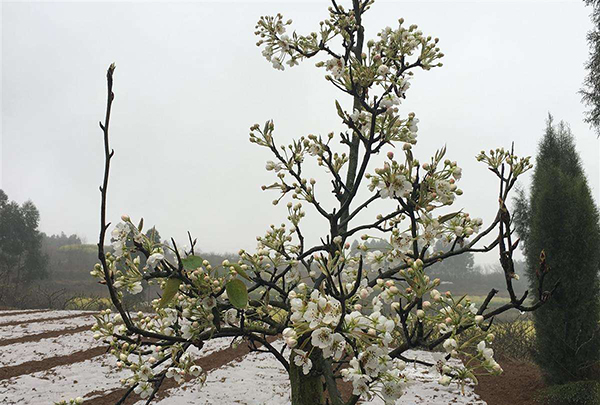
[0,0,600,263]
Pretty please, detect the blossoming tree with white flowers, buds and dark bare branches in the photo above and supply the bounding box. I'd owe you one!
[92,0,556,405]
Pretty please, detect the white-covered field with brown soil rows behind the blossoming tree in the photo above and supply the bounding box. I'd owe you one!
[0,310,494,405]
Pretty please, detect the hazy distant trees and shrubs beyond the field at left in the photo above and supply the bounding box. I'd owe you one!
[0,190,235,309]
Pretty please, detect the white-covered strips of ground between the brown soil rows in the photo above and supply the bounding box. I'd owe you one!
[0,311,485,405]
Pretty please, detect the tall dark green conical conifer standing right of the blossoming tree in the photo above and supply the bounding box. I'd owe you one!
[515,116,600,384]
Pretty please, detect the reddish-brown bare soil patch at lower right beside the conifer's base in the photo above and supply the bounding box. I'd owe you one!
[475,360,544,405]
